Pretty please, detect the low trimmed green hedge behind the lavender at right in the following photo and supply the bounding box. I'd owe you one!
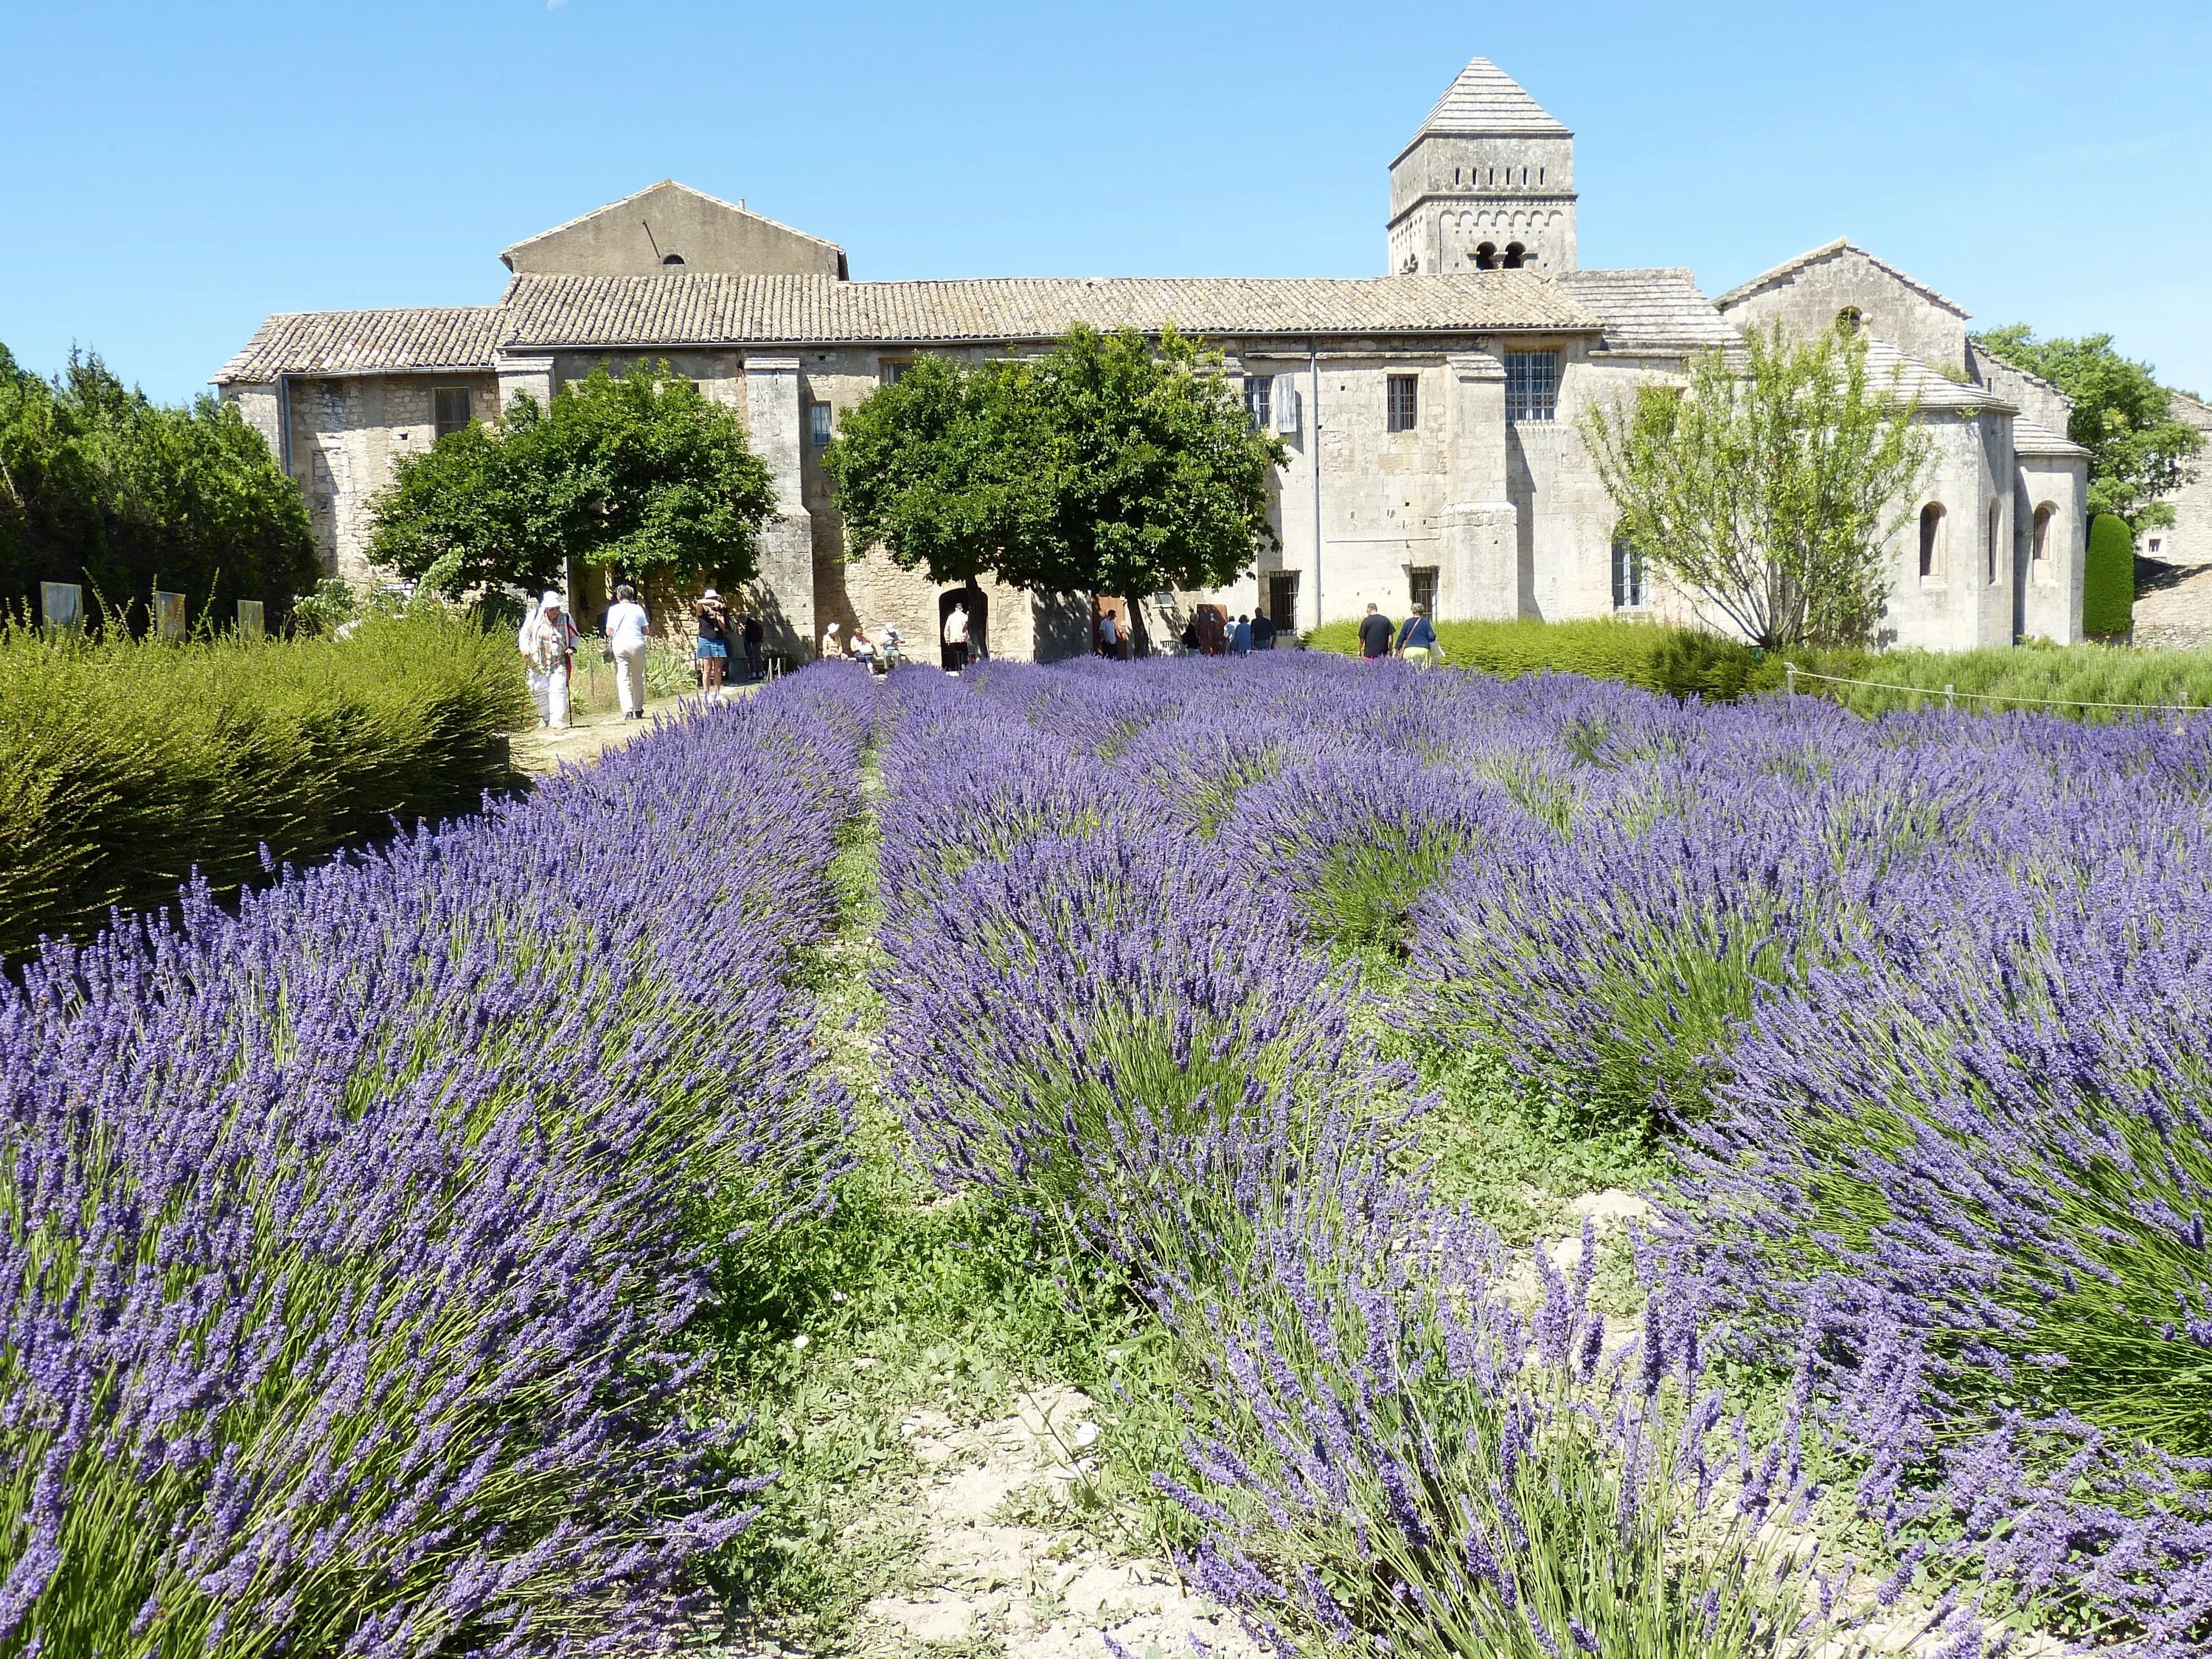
[1307,619,2212,719]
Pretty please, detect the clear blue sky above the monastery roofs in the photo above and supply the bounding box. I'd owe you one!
[0,0,2212,398]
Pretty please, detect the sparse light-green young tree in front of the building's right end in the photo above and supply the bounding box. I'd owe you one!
[1582,327,1931,650]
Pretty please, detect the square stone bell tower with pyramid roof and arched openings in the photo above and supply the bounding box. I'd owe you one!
[1389,58,1575,276]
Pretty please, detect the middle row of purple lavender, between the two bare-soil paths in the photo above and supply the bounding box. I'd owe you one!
[854,664,1893,1657]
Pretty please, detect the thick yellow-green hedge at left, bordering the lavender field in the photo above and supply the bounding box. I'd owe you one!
[0,611,531,956]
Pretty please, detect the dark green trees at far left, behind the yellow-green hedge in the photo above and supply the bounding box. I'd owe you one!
[0,345,319,624]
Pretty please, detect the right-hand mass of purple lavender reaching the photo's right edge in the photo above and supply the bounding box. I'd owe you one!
[1168,655,2212,1655]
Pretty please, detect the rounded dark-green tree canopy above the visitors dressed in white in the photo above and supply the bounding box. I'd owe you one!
[369,363,776,593]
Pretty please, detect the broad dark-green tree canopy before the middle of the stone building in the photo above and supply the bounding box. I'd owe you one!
[823,327,1283,593]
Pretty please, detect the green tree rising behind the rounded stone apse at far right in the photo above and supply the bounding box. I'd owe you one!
[1973,323,2203,531]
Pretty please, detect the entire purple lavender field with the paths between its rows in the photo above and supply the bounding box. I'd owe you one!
[0,653,2212,1659]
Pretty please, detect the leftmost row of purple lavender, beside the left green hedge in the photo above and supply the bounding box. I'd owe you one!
[0,677,869,1659]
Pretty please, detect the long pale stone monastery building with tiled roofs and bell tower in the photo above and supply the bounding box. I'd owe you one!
[217,58,2088,657]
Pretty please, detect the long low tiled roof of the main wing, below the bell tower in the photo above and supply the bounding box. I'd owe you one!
[489,270,1599,347]
